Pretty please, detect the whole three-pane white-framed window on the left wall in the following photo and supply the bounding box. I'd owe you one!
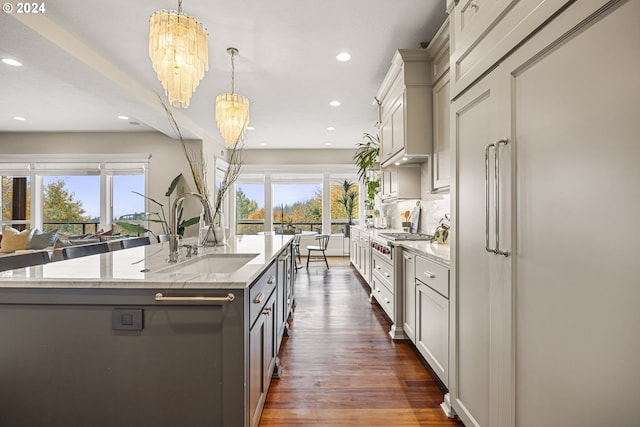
[0,154,149,234]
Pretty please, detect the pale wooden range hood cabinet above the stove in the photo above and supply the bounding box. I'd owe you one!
[376,49,433,167]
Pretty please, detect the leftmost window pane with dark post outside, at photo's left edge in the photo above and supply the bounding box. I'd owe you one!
[0,176,31,230]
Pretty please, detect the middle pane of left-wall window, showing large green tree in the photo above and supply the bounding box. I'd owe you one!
[43,175,100,234]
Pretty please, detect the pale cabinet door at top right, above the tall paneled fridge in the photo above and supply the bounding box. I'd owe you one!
[449,0,569,98]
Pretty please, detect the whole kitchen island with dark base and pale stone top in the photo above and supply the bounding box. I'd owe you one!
[0,236,293,427]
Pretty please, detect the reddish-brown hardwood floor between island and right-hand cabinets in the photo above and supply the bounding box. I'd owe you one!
[260,258,462,427]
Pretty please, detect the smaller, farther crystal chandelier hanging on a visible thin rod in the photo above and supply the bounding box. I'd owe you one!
[216,47,249,148]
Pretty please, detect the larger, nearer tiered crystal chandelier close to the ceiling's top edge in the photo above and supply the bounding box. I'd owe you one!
[149,0,209,108]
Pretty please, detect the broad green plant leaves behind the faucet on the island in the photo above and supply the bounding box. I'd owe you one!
[116,174,200,242]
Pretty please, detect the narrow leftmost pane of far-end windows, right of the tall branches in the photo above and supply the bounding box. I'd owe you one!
[236,183,264,234]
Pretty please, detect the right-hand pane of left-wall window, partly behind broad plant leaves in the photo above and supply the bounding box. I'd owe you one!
[112,175,148,234]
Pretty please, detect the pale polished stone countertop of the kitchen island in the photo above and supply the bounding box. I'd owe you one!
[0,235,293,289]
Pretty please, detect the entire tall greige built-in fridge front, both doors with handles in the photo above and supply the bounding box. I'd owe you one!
[449,0,640,427]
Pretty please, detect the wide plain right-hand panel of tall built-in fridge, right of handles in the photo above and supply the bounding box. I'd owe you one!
[504,0,640,427]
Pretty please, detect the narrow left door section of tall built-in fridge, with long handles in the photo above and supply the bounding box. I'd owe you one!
[449,69,512,427]
